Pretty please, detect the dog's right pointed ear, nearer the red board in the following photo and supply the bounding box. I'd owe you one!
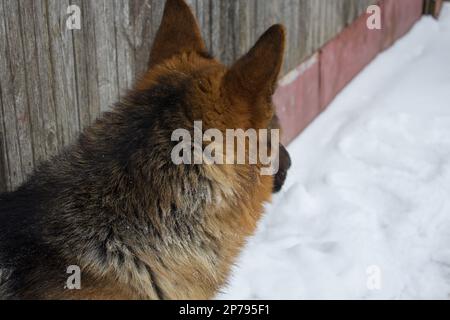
[224,25,286,99]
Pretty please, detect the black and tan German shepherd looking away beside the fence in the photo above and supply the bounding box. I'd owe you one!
[0,0,290,300]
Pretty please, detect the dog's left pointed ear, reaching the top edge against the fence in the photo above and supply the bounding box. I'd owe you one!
[149,0,206,67]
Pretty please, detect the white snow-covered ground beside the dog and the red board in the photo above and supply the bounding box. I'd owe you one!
[219,5,450,299]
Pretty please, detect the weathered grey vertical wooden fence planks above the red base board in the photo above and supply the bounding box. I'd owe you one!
[0,0,376,191]
